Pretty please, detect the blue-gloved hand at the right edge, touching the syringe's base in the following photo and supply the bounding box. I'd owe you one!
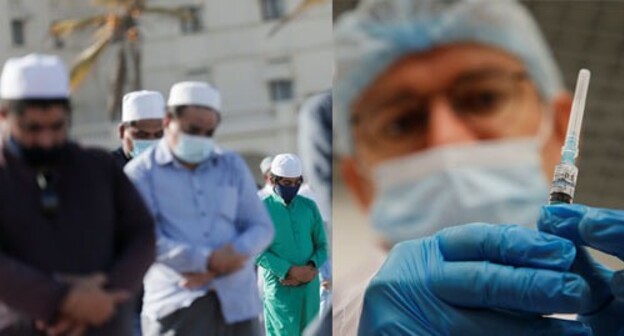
[538,204,624,335]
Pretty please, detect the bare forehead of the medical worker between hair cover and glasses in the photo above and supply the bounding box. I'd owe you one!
[352,43,524,108]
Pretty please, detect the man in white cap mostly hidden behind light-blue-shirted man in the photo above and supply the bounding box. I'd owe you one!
[112,91,165,167]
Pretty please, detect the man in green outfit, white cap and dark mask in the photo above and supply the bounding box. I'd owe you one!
[256,154,327,336]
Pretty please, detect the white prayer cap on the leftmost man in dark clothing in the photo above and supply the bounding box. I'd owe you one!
[0,54,69,99]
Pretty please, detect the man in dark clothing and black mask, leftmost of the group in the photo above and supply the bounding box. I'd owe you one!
[0,54,154,335]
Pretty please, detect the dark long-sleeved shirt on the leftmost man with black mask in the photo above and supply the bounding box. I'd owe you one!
[0,143,154,320]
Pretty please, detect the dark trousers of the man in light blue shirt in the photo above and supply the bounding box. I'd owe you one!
[141,292,260,336]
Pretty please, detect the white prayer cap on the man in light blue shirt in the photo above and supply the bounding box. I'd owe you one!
[167,82,221,111]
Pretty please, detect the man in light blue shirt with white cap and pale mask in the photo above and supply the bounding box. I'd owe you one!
[125,82,274,336]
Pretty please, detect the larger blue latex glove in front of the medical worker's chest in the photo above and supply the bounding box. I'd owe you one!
[358,223,591,336]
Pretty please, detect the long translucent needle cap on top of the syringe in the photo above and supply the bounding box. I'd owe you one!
[561,69,591,164]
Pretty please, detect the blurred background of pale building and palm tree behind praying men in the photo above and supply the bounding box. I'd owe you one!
[0,0,333,181]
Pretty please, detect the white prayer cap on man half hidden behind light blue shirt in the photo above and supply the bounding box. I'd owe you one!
[121,91,165,122]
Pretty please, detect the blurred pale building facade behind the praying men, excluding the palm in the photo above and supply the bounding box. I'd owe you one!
[0,0,333,178]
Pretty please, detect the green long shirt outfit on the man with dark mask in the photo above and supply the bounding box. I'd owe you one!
[256,194,327,336]
